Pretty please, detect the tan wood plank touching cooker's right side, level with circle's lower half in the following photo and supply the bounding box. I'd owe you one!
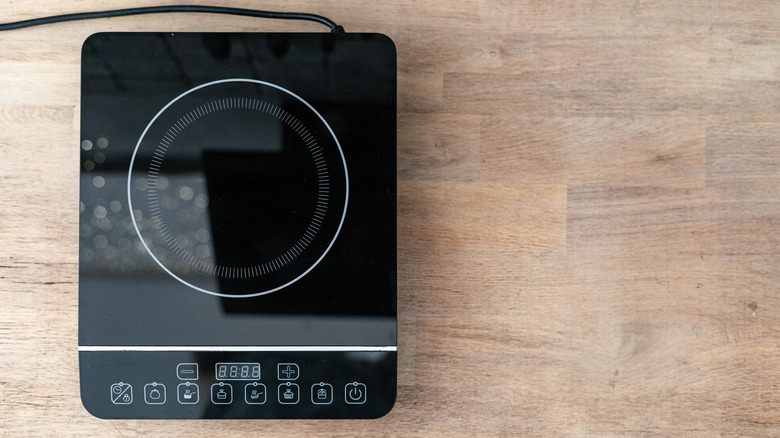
[398,182,566,252]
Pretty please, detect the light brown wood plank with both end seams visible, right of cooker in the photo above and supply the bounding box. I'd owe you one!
[482,115,705,188]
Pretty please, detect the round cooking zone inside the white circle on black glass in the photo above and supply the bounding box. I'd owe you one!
[127,79,349,297]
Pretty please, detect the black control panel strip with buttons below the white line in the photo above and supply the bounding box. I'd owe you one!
[79,350,396,419]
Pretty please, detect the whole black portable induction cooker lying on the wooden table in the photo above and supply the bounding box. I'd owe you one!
[79,33,397,418]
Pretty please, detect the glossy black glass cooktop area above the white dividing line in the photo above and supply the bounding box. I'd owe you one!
[79,34,396,345]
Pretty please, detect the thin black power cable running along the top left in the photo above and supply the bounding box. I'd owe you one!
[0,5,344,33]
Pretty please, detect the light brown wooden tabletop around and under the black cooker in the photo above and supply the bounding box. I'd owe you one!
[0,0,780,437]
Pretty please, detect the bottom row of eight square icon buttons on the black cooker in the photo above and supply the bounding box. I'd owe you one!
[110,382,367,405]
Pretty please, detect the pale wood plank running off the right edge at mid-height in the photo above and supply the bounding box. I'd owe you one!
[567,187,780,256]
